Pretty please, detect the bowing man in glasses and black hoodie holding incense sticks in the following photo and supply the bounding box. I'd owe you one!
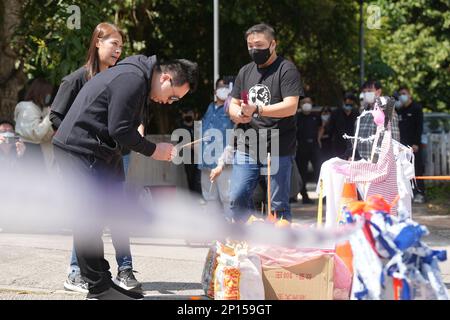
[53,55,198,300]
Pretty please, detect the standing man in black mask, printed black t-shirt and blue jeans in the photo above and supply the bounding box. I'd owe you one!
[230,24,303,221]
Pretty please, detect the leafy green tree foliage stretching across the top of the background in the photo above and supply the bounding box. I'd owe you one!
[8,0,450,132]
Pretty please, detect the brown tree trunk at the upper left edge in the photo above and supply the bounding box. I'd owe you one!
[0,0,26,120]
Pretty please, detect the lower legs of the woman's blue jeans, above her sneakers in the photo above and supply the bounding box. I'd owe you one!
[70,222,133,273]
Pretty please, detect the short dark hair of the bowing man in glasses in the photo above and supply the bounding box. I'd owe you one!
[156,59,198,93]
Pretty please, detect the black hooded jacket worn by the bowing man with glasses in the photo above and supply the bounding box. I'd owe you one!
[53,55,157,163]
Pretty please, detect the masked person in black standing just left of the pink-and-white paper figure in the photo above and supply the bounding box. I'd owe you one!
[328,92,358,160]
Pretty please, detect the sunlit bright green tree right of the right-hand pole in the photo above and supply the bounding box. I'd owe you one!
[366,0,450,111]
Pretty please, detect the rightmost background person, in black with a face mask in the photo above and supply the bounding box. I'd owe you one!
[397,86,425,203]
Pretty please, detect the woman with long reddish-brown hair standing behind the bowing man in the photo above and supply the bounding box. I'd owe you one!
[50,22,141,293]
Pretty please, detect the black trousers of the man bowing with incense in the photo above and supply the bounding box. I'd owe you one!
[54,146,123,293]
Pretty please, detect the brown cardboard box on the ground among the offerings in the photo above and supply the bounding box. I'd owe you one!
[262,253,334,300]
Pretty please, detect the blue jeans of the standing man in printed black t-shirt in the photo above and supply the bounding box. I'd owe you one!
[230,151,294,221]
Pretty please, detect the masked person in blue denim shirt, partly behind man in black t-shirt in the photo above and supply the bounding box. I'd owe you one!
[198,78,234,218]
